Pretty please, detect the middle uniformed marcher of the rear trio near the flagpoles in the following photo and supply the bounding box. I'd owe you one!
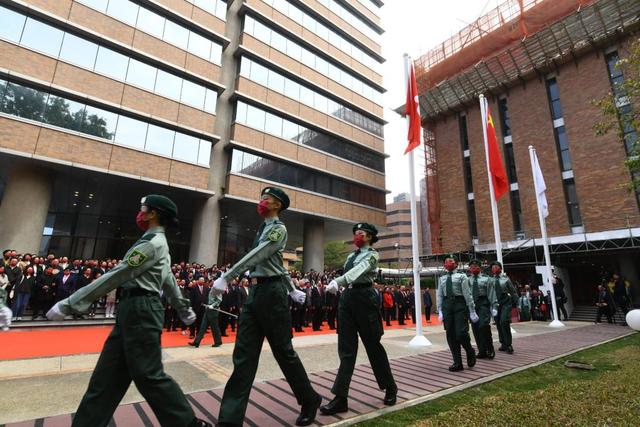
[469,259,498,359]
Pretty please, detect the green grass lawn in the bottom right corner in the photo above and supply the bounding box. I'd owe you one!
[358,334,640,427]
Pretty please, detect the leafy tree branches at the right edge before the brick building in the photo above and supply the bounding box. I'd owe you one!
[593,39,640,191]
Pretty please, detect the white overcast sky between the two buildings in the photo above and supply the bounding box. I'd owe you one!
[382,0,502,202]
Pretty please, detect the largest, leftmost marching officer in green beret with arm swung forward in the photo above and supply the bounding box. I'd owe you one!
[47,194,211,427]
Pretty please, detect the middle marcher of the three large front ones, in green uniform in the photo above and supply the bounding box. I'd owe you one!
[213,187,322,426]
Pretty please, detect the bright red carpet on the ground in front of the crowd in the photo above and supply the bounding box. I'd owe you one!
[0,316,438,360]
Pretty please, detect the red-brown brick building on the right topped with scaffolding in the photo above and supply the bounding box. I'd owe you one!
[416,0,640,305]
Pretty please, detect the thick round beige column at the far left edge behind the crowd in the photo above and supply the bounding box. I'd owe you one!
[0,163,51,253]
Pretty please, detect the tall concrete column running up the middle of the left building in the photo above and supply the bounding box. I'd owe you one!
[189,1,244,266]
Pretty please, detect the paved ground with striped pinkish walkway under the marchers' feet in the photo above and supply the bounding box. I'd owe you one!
[0,322,631,427]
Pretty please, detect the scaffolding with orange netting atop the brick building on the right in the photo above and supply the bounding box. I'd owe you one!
[415,0,640,119]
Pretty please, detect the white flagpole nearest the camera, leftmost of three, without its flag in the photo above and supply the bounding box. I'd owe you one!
[398,53,431,347]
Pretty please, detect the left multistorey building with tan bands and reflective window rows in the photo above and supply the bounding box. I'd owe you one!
[0,0,386,270]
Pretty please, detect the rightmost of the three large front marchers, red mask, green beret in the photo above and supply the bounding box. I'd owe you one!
[320,223,398,415]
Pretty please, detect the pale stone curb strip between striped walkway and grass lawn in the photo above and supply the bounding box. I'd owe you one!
[327,330,638,427]
